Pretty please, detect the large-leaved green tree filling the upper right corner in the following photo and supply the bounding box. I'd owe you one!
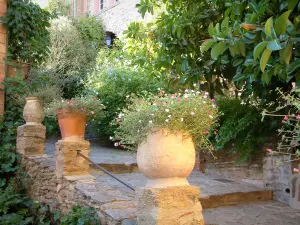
[125,0,300,102]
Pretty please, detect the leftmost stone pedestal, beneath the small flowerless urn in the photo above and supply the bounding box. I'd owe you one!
[17,123,46,156]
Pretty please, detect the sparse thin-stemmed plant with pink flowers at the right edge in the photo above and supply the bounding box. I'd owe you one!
[262,83,300,174]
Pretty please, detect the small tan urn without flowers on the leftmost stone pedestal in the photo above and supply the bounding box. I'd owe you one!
[23,97,44,124]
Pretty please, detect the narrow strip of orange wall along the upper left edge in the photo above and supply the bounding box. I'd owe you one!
[0,0,7,116]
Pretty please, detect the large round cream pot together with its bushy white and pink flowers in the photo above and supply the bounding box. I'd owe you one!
[113,90,217,187]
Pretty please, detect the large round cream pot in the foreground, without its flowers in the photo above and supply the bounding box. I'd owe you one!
[137,129,196,188]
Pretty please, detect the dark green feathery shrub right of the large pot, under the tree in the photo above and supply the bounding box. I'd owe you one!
[213,97,277,161]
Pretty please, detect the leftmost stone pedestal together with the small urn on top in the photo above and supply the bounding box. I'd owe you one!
[17,98,46,156]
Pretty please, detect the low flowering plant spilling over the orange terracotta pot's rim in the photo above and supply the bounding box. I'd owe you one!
[45,96,105,116]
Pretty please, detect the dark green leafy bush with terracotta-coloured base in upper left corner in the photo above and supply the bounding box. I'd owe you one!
[0,0,51,79]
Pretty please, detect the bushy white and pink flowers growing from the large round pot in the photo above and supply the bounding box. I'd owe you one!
[111,90,217,150]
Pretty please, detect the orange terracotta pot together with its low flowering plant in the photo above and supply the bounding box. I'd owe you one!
[45,96,105,139]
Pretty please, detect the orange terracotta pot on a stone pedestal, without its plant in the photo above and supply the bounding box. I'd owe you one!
[56,109,86,139]
